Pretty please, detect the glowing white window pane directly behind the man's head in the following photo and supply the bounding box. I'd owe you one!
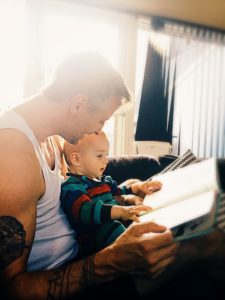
[42,14,119,152]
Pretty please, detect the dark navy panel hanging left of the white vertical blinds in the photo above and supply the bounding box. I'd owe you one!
[135,39,175,143]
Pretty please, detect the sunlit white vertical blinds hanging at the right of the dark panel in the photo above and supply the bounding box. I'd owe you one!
[139,18,225,157]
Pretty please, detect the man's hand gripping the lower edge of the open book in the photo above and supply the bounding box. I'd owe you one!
[95,222,177,280]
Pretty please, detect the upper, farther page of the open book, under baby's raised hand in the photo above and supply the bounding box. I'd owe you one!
[144,158,218,209]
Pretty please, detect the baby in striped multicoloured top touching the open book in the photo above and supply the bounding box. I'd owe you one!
[61,132,161,256]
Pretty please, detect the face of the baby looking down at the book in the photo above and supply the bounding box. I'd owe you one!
[80,136,109,178]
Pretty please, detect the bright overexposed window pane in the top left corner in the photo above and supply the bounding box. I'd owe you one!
[0,0,26,110]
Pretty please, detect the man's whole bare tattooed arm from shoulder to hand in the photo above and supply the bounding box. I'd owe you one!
[0,130,176,300]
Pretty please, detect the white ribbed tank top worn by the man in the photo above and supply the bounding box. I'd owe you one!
[0,111,78,271]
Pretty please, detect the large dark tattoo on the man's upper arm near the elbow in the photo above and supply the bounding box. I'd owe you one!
[0,216,26,268]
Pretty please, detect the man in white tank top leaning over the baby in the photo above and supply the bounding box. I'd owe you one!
[0,53,176,299]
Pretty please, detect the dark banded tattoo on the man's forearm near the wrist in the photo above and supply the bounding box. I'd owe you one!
[47,255,96,300]
